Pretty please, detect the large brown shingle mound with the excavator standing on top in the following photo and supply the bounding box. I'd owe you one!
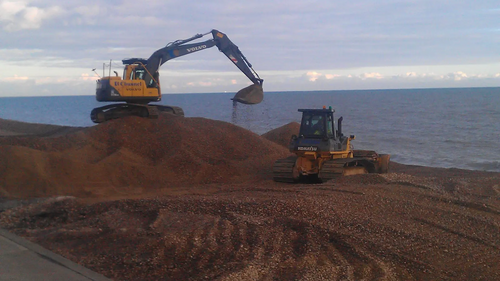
[0,114,288,198]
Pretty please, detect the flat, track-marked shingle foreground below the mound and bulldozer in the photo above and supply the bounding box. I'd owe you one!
[0,179,498,280]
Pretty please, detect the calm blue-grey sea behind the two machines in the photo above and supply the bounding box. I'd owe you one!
[0,88,500,172]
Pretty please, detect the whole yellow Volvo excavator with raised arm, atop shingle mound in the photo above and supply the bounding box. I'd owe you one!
[90,29,264,123]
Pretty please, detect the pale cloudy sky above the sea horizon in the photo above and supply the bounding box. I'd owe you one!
[0,0,500,97]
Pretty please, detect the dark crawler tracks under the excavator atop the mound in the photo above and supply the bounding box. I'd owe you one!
[90,103,184,123]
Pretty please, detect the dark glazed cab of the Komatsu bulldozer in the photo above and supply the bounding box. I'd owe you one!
[299,109,335,139]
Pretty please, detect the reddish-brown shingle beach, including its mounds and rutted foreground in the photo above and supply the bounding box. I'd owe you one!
[0,115,500,280]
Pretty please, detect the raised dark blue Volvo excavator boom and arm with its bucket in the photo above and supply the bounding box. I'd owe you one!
[144,29,264,104]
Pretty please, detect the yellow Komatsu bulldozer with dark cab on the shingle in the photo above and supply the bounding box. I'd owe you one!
[273,107,390,182]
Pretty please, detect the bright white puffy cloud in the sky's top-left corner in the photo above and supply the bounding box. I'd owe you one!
[0,0,63,32]
